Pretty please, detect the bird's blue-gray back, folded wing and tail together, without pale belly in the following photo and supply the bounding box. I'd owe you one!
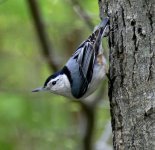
[67,18,109,98]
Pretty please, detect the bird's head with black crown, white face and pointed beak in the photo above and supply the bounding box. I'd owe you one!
[32,72,71,96]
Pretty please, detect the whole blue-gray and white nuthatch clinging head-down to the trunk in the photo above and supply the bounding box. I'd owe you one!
[32,17,109,99]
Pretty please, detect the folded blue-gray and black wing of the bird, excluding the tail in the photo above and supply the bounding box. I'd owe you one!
[71,41,95,98]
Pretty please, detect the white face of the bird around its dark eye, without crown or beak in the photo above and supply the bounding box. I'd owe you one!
[46,74,71,97]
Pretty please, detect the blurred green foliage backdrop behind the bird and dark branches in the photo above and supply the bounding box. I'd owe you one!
[0,0,110,150]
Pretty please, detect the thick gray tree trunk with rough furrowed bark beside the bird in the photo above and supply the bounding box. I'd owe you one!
[99,0,155,150]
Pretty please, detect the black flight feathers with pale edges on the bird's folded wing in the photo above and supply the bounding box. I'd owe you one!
[71,42,95,97]
